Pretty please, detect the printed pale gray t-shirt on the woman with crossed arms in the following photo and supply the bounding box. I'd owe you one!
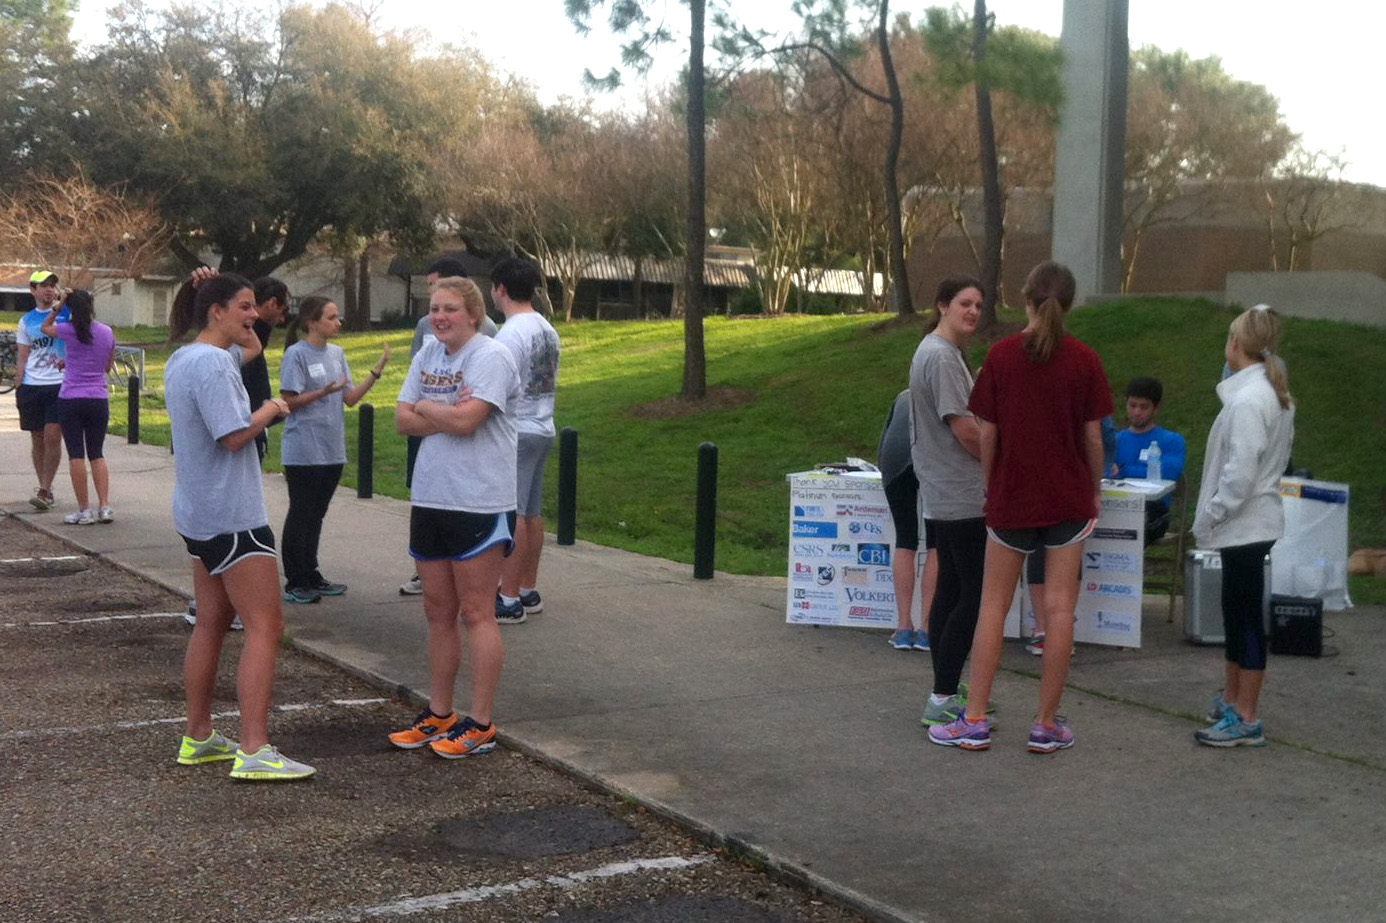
[399,337,520,513]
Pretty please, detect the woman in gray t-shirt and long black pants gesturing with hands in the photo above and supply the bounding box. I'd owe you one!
[279,295,389,603]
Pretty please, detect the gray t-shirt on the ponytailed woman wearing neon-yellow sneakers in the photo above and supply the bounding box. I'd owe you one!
[164,342,269,540]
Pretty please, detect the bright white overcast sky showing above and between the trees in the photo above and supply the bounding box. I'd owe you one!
[75,0,1386,186]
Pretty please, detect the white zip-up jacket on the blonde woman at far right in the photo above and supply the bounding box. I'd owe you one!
[1193,362,1295,547]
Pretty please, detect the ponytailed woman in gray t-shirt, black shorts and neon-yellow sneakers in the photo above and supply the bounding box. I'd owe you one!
[164,274,313,782]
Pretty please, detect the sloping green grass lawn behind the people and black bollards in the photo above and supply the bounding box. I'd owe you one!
[97,299,1386,601]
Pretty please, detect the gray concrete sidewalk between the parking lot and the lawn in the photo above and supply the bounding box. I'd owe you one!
[0,426,1386,923]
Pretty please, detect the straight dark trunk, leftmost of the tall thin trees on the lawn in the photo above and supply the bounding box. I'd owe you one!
[679,0,707,401]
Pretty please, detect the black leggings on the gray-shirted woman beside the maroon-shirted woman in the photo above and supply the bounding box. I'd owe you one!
[929,518,987,696]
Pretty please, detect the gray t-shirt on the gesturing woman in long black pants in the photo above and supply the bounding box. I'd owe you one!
[279,340,352,464]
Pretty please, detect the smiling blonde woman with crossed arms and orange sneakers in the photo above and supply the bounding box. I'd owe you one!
[389,277,520,759]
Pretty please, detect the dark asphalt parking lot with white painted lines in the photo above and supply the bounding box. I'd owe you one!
[0,517,862,923]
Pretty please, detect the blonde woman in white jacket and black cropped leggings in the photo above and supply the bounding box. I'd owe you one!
[1193,305,1295,747]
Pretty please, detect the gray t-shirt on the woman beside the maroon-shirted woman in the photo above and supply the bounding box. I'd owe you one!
[909,334,983,521]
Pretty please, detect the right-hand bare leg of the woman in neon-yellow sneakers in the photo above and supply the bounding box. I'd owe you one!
[221,554,284,753]
